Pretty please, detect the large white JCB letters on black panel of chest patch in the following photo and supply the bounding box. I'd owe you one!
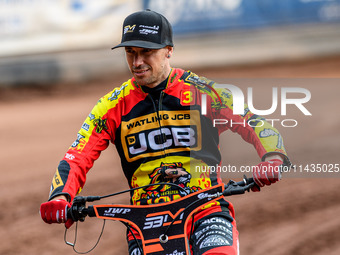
[125,126,197,158]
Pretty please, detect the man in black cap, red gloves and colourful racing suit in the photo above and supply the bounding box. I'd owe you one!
[40,10,289,255]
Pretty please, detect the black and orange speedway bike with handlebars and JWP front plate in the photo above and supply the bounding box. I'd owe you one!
[64,176,254,255]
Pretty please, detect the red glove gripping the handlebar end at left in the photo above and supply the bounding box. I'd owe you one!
[40,199,73,228]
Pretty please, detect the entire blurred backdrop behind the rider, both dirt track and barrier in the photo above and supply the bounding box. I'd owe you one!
[0,0,340,255]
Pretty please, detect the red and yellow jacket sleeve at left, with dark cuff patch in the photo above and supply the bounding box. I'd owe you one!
[50,95,114,201]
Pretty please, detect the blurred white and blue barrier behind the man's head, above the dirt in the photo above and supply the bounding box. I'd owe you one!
[0,0,340,86]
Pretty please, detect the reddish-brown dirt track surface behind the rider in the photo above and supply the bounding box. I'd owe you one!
[0,57,340,255]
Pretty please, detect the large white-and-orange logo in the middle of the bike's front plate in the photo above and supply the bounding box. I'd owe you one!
[143,209,183,229]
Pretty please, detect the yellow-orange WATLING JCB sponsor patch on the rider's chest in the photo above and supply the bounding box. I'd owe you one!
[121,110,202,162]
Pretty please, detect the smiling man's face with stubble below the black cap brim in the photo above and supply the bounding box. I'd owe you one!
[125,47,173,88]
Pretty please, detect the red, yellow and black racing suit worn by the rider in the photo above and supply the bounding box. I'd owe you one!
[50,68,286,254]
